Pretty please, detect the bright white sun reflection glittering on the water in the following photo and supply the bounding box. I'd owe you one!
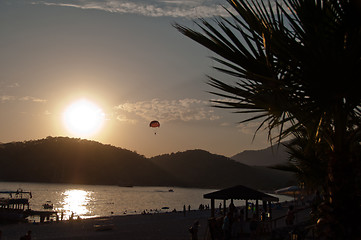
[58,189,92,219]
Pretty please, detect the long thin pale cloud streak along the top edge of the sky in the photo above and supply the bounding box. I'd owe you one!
[33,0,226,18]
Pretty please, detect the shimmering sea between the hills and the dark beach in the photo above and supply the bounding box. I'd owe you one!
[0,182,290,220]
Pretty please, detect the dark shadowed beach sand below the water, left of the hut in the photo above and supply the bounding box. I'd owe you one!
[0,210,210,240]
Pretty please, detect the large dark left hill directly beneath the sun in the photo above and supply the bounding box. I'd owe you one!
[0,137,181,186]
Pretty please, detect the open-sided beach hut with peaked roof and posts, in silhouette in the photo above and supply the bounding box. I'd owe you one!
[203,185,279,219]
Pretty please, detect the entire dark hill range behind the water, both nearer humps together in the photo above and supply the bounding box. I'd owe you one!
[0,137,294,190]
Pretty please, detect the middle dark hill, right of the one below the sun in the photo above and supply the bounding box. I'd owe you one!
[150,150,294,190]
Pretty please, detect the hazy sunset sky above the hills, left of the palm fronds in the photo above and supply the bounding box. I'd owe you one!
[0,0,270,157]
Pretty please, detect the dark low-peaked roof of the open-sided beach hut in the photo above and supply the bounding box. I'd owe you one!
[203,185,279,202]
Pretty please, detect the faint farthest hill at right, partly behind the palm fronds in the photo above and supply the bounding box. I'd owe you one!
[231,144,289,166]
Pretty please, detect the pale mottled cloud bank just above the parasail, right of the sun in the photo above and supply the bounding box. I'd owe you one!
[115,98,220,123]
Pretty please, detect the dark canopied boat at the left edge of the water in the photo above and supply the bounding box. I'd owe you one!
[0,188,32,223]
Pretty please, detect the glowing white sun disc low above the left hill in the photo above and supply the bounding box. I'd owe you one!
[63,99,105,137]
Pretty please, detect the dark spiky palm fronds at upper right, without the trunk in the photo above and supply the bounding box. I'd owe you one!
[174,0,361,148]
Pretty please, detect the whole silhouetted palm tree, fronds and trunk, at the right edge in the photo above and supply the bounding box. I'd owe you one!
[174,0,361,239]
